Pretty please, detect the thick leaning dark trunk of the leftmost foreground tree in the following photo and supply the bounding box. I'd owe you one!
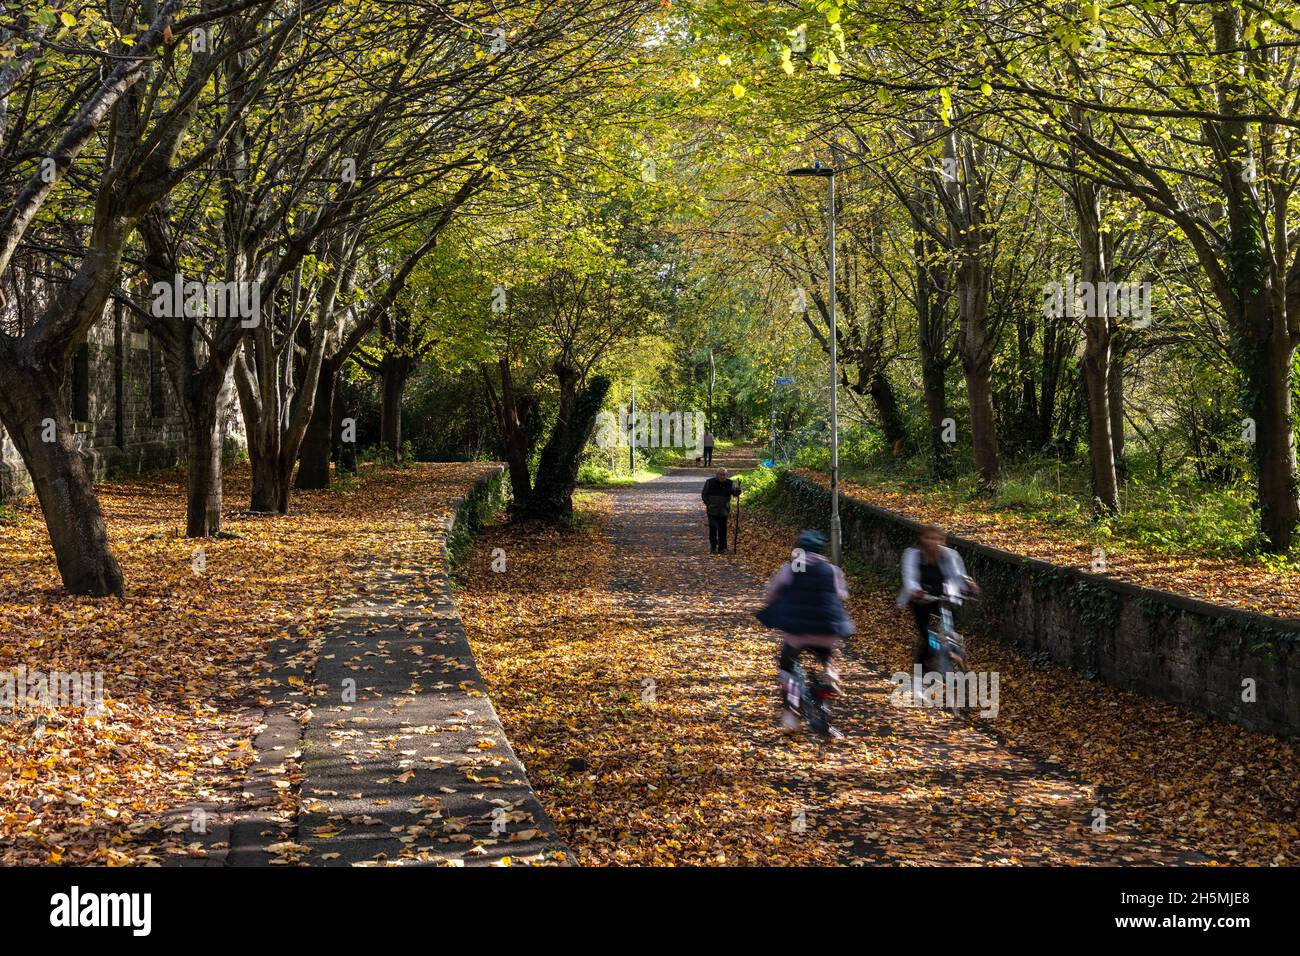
[0,360,122,597]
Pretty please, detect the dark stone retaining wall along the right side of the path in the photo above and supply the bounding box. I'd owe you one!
[776,472,1300,736]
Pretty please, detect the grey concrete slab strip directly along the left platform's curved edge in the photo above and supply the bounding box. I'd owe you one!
[296,494,567,866]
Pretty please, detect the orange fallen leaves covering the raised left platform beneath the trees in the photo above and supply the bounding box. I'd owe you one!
[0,464,484,865]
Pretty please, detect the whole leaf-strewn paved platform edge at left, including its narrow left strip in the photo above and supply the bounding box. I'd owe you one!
[165,476,569,866]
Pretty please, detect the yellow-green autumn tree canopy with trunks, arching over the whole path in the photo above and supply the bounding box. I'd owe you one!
[0,0,1300,596]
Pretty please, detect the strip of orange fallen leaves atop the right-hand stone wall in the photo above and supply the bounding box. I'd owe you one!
[796,468,1300,618]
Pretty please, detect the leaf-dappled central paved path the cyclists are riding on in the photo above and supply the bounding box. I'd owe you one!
[608,462,1197,865]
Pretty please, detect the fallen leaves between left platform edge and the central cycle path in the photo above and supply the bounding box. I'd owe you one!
[456,493,836,866]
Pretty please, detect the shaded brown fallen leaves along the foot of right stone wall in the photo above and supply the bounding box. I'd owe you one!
[741,494,1300,866]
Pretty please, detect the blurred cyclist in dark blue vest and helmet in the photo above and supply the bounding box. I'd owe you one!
[758,531,857,731]
